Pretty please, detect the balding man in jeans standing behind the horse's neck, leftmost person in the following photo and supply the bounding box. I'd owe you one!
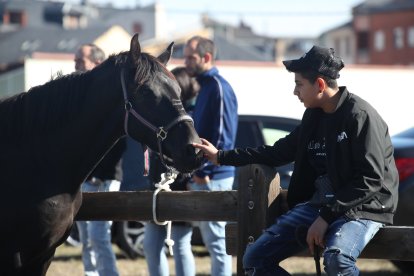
[75,43,126,276]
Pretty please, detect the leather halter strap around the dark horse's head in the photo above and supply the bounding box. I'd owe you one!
[121,68,194,168]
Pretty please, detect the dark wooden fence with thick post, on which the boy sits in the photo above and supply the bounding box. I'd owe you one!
[76,165,414,275]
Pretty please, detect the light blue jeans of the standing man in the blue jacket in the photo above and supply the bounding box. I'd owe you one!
[190,177,234,276]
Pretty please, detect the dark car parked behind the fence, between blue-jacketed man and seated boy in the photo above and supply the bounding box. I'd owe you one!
[67,115,300,259]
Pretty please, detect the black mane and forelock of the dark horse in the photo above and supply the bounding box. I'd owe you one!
[0,52,172,141]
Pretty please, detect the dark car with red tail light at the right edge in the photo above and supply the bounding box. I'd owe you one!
[391,127,414,275]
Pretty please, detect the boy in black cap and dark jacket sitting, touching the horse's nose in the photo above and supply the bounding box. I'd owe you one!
[194,46,398,275]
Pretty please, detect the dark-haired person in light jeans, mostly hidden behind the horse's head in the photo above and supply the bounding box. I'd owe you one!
[144,67,199,276]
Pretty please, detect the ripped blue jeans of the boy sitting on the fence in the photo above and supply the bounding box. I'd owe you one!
[243,203,383,276]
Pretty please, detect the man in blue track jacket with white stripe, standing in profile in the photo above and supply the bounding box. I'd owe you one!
[184,36,238,276]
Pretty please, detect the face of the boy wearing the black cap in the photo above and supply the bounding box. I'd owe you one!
[293,73,322,108]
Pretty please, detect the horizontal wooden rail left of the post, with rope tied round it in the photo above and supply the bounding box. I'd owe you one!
[76,191,237,221]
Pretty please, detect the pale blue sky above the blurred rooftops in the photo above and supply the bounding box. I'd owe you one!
[73,0,363,37]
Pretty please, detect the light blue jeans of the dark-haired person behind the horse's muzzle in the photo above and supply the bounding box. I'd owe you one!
[144,222,195,276]
